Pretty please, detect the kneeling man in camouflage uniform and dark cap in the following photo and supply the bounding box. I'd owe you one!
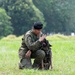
[19,22,46,69]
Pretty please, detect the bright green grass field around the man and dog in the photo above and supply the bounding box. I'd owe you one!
[0,35,75,75]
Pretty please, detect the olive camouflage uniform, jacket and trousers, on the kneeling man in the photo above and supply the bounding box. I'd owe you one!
[19,30,45,69]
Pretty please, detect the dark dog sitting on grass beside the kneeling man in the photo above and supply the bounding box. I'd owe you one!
[40,39,53,70]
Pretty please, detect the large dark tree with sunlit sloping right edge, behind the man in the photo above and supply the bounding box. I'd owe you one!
[2,0,45,35]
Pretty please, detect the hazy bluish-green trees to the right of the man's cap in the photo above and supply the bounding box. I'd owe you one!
[33,0,75,34]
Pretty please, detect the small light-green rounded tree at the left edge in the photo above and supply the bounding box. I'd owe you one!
[0,8,13,37]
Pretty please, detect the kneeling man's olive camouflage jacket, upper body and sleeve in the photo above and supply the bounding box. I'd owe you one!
[21,30,42,52]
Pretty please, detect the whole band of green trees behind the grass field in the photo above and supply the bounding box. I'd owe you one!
[0,0,75,36]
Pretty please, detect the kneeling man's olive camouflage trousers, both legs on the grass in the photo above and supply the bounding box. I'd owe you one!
[19,50,45,69]
